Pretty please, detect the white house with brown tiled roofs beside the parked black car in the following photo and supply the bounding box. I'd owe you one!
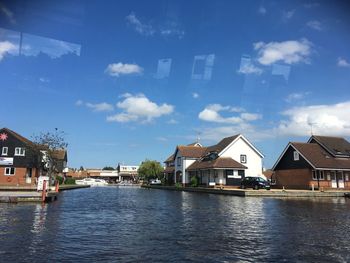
[166,134,264,186]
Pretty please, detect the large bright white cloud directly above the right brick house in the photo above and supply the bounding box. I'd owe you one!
[275,101,350,136]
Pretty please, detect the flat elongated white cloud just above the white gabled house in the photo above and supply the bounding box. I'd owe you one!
[198,104,262,124]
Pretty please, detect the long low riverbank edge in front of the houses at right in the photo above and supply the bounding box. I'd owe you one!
[142,185,350,197]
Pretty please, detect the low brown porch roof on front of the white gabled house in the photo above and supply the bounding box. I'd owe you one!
[187,157,247,170]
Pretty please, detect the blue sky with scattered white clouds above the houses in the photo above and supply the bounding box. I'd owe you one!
[0,0,350,168]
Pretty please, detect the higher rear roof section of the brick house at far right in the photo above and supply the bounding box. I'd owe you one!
[309,135,350,157]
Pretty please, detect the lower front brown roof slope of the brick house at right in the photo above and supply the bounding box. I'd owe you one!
[290,142,350,169]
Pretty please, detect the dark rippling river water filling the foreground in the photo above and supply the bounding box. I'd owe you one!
[0,187,350,262]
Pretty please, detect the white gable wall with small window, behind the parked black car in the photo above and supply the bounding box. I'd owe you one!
[220,138,262,176]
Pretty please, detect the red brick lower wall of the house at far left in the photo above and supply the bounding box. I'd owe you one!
[0,167,39,186]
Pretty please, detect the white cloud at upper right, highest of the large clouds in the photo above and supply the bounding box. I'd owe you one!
[254,39,312,65]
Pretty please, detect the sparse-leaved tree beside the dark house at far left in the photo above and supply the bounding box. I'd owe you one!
[32,128,68,184]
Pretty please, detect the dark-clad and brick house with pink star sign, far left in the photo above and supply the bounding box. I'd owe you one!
[0,128,41,186]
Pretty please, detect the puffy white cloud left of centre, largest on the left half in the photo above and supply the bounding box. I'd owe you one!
[107,94,174,123]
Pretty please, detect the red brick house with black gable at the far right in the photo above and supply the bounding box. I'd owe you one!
[272,135,350,189]
